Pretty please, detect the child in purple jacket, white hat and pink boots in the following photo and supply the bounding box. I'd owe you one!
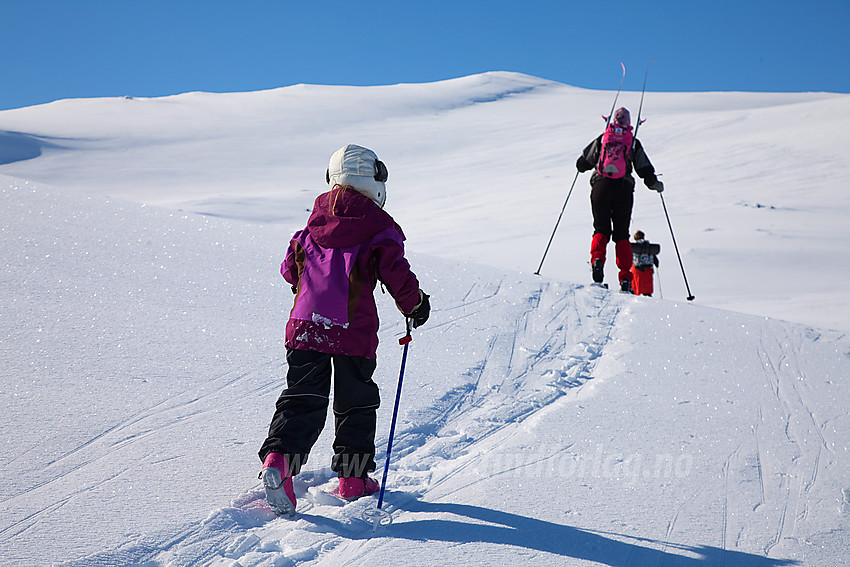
[259,145,431,516]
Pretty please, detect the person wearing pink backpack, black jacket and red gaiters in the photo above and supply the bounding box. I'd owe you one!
[576,108,664,292]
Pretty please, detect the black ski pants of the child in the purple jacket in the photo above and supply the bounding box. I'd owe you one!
[259,348,381,477]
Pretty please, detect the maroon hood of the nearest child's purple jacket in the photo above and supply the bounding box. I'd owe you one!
[307,187,404,248]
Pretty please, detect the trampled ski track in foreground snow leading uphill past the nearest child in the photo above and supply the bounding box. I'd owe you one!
[56,282,624,567]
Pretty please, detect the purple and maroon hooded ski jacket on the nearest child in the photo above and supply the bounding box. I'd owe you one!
[280,186,419,358]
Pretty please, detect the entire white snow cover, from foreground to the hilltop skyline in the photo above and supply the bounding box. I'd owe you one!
[0,73,850,567]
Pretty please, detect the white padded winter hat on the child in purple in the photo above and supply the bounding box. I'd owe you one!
[325,144,387,208]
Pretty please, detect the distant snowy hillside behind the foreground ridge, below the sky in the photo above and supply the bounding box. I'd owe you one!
[0,75,850,331]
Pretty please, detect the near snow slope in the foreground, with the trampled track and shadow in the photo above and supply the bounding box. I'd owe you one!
[2,182,850,567]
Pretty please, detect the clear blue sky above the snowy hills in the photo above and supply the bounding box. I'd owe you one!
[0,0,850,110]
